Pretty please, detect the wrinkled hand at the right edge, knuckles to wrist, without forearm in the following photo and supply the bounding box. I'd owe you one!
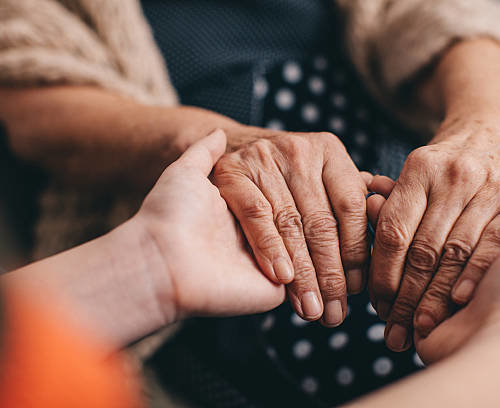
[369,120,500,351]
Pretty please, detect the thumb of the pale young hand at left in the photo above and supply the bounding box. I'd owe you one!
[175,129,227,176]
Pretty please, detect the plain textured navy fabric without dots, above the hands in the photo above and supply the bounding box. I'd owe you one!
[142,0,335,124]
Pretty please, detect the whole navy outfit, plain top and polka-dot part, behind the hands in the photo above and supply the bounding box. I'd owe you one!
[142,0,426,407]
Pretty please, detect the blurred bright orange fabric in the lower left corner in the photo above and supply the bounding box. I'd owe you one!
[0,294,144,408]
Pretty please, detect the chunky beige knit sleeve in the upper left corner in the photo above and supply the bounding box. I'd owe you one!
[0,0,177,105]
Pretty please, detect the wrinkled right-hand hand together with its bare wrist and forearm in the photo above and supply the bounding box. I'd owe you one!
[369,39,500,351]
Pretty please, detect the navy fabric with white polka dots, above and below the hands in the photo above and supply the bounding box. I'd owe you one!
[254,53,422,405]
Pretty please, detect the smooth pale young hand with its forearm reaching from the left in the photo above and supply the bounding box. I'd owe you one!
[0,130,285,350]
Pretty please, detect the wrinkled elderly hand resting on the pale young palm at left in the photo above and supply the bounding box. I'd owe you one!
[214,127,368,326]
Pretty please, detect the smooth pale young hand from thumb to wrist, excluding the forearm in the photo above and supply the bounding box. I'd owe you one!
[134,130,285,319]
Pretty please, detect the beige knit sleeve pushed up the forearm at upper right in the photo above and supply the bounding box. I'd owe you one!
[337,0,500,132]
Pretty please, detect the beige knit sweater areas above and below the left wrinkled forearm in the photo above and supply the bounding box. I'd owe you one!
[0,0,177,259]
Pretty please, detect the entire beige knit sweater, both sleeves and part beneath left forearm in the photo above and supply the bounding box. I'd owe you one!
[0,0,500,258]
